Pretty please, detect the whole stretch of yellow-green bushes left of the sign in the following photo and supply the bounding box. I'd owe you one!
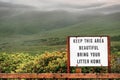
[0,52,66,73]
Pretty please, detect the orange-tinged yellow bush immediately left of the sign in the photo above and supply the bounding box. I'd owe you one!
[14,52,66,73]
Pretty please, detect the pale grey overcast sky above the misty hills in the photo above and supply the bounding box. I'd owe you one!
[0,0,120,11]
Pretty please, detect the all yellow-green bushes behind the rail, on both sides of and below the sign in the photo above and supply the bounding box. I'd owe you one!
[0,51,120,73]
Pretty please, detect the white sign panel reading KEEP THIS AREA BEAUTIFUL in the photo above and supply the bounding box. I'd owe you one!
[69,37,108,66]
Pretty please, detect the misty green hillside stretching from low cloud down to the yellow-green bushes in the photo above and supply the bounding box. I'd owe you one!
[0,11,120,53]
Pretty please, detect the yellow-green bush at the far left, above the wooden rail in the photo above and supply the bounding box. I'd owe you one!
[0,53,33,73]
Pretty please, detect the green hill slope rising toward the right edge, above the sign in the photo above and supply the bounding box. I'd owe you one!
[48,13,120,36]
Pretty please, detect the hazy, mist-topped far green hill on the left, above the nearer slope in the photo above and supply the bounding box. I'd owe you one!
[0,11,81,35]
